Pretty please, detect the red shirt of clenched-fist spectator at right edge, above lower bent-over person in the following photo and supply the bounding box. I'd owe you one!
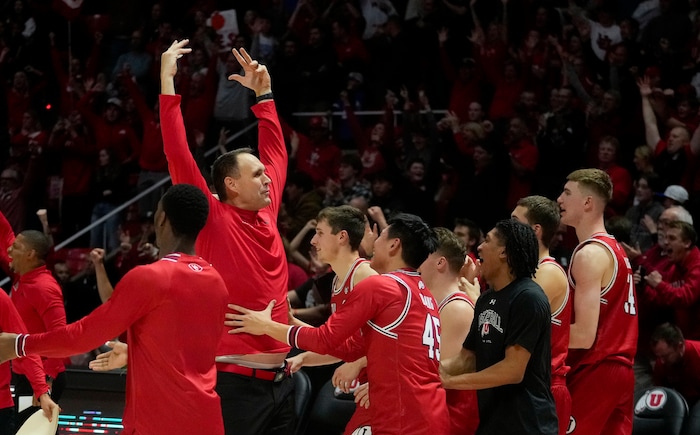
[644,246,700,340]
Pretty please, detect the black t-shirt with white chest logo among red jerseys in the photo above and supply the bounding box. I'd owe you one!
[463,278,558,435]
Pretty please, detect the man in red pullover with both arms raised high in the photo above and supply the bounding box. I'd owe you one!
[160,39,295,435]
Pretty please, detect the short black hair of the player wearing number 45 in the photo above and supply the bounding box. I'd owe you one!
[387,213,437,269]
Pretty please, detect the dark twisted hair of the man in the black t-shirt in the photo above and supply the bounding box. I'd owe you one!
[495,219,539,278]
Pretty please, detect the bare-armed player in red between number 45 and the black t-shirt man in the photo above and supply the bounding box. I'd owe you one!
[418,228,479,435]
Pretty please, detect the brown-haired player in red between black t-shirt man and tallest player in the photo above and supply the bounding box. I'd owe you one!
[511,196,571,435]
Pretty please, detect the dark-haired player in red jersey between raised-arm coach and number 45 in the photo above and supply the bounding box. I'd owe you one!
[288,205,377,434]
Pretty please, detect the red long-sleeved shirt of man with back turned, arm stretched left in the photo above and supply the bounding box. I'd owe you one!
[24,253,227,435]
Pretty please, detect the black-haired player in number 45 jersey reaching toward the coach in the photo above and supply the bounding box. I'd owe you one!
[226,214,449,435]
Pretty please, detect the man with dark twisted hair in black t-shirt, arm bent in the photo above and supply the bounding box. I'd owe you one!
[440,219,558,435]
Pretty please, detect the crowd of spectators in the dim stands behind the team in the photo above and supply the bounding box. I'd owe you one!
[0,0,700,410]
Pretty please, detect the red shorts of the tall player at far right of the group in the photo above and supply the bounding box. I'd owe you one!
[567,361,634,435]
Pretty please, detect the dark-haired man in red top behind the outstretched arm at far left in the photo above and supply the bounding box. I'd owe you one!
[0,213,66,400]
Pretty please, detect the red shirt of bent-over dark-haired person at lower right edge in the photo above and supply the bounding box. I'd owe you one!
[653,340,700,407]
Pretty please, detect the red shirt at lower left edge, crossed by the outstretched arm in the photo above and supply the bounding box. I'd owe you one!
[0,291,49,409]
